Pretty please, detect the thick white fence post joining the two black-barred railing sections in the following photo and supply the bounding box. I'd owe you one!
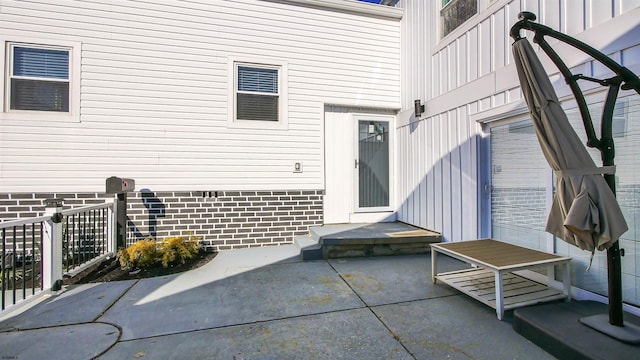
[42,199,62,291]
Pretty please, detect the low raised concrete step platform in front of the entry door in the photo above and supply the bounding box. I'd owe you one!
[296,222,442,260]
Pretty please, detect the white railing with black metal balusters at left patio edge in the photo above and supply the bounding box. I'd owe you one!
[0,200,116,310]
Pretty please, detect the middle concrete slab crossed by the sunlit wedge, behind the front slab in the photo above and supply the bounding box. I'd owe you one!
[99,260,364,340]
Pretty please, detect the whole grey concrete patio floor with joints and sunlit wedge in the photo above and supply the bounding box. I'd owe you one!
[0,246,552,360]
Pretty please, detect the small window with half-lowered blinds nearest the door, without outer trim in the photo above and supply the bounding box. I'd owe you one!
[236,65,280,121]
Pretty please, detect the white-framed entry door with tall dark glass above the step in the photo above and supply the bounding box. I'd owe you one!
[353,115,393,212]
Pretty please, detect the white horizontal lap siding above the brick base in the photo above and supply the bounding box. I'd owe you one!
[0,0,400,192]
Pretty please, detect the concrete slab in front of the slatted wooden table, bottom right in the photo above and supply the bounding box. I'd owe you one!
[373,295,554,360]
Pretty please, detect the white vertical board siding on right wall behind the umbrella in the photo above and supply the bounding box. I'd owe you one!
[397,0,640,241]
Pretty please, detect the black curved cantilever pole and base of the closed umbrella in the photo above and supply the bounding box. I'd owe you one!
[510,12,640,344]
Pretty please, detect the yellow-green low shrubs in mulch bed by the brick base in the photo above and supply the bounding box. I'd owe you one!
[118,235,202,269]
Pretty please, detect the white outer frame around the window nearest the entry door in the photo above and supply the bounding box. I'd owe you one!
[227,57,289,130]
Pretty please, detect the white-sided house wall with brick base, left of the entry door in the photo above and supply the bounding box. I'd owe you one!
[0,0,403,250]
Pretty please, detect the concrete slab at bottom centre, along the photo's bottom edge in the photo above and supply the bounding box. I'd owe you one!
[101,308,413,360]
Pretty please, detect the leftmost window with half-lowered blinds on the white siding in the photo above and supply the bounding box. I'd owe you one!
[8,44,70,112]
